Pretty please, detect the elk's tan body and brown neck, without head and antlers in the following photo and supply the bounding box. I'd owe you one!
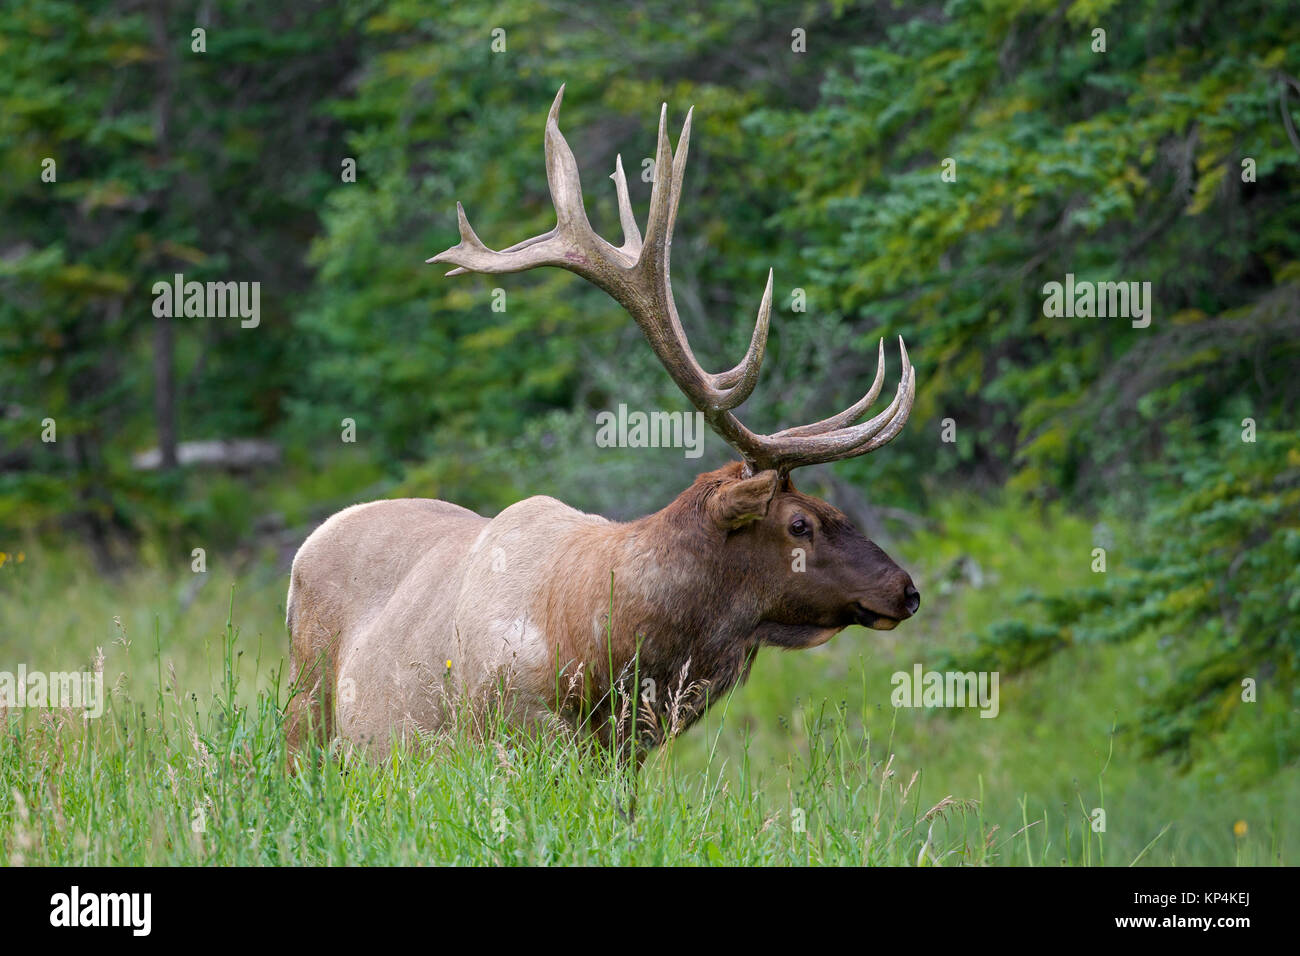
[287,468,759,756]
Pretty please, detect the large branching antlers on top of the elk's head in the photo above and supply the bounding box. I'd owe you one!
[428,86,917,473]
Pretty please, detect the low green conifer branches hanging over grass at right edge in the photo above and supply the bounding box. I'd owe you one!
[945,428,1300,778]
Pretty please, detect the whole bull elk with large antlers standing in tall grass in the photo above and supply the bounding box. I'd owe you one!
[287,87,920,756]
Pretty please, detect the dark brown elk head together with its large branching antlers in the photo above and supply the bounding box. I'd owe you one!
[428,86,920,646]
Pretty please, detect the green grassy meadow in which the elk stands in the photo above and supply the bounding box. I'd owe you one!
[0,502,1300,865]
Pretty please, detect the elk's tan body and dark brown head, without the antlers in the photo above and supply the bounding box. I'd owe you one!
[287,463,919,756]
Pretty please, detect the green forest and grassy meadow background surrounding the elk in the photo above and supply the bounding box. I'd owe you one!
[0,0,1300,864]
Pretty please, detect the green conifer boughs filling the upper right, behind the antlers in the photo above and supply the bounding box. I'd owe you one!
[751,1,1300,494]
